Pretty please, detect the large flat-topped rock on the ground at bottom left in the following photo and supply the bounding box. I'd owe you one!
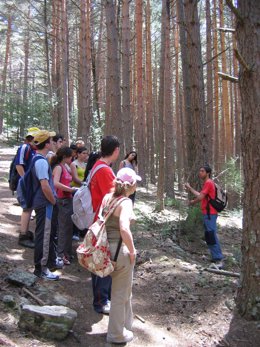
[19,305,77,340]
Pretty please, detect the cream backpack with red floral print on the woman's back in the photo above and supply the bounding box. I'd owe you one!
[77,197,127,277]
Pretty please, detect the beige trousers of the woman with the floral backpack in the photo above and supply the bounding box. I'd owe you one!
[107,243,134,342]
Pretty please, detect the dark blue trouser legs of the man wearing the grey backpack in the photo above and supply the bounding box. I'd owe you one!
[91,274,112,312]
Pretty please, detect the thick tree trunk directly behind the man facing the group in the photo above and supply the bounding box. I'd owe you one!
[184,0,208,188]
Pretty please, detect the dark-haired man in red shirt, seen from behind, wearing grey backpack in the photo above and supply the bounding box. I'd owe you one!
[90,136,119,314]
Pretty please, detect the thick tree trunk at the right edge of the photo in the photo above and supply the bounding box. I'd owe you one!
[236,0,260,320]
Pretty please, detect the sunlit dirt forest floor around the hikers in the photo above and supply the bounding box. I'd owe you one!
[0,144,260,347]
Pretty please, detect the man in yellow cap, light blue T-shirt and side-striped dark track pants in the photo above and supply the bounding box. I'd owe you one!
[31,130,59,280]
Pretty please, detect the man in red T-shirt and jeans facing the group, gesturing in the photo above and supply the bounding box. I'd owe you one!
[185,165,223,269]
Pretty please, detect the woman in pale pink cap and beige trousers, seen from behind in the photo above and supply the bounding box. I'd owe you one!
[102,168,141,343]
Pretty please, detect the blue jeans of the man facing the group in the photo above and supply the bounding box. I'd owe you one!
[203,214,223,261]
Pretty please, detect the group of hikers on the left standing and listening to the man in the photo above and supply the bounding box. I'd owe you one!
[13,128,141,343]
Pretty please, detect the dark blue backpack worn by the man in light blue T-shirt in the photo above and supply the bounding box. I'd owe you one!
[17,155,42,209]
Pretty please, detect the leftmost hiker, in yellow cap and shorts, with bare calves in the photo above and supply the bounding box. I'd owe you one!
[15,127,40,248]
